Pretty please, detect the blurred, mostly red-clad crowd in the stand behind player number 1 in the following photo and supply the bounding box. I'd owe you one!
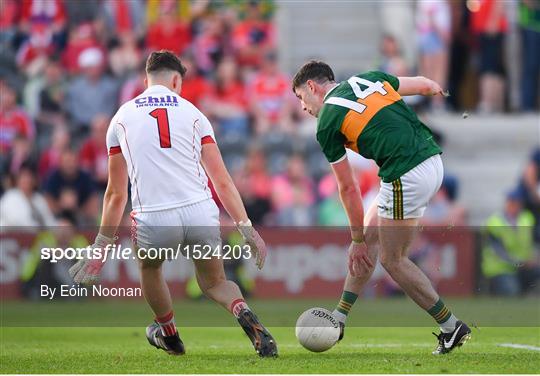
[0,0,476,232]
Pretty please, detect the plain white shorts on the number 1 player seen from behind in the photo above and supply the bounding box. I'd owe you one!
[131,199,221,249]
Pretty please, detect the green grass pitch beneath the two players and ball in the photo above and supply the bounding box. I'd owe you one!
[0,299,540,373]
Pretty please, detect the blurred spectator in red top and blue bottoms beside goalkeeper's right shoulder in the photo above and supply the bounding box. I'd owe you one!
[207,57,249,137]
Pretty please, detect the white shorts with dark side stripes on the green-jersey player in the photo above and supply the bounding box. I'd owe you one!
[377,154,444,219]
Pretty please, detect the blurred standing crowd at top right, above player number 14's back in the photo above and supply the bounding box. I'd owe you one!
[380,0,540,114]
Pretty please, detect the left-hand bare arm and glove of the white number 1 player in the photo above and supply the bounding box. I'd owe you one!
[69,153,128,284]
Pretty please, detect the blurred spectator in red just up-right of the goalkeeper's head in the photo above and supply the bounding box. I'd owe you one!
[192,14,229,77]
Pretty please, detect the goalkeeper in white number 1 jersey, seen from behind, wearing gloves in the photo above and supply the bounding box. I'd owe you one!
[70,51,277,357]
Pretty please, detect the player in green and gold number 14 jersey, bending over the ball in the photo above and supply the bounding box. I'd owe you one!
[293,61,471,354]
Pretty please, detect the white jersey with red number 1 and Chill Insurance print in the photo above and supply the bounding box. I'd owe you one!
[107,85,215,212]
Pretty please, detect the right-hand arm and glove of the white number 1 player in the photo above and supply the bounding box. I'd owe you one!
[201,143,266,269]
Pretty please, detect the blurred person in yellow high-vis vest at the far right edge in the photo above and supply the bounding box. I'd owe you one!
[482,190,540,296]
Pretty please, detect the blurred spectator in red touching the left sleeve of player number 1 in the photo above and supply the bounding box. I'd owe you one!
[79,114,111,193]
